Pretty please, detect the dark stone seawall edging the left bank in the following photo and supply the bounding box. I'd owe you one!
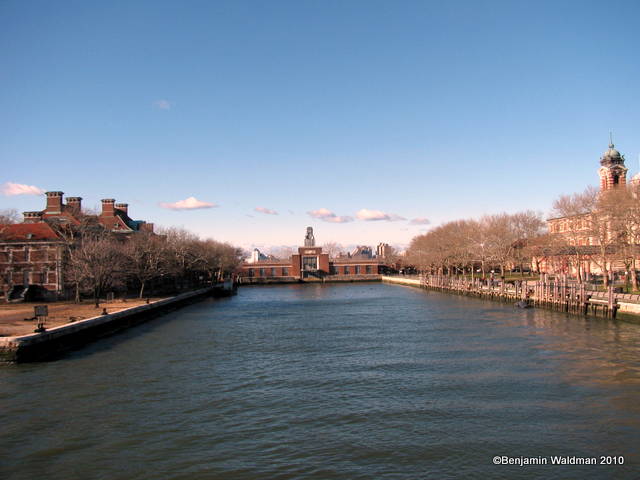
[0,287,222,363]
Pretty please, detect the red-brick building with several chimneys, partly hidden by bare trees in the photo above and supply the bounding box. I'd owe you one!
[0,191,153,300]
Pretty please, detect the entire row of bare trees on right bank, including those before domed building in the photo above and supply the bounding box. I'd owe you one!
[405,185,640,290]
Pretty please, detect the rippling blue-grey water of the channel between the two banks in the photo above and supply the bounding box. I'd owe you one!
[0,284,640,480]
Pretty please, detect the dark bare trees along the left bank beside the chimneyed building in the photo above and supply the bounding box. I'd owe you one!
[53,216,243,301]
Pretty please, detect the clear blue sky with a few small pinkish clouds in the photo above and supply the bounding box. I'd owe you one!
[0,0,640,253]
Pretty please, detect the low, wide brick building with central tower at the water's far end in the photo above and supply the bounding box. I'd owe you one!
[239,227,386,283]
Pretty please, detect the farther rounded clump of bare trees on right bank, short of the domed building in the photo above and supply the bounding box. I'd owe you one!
[405,210,544,278]
